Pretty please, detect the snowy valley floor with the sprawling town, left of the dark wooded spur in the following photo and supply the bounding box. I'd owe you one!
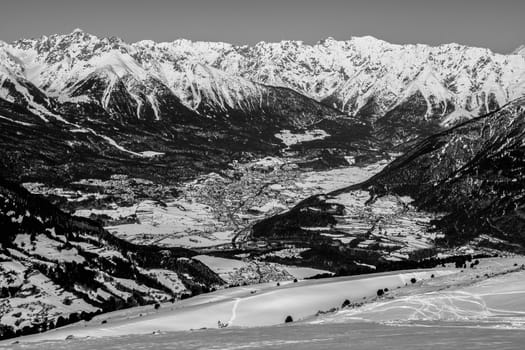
[62,157,387,249]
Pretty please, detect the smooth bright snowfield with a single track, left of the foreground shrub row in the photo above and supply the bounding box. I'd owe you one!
[5,269,450,341]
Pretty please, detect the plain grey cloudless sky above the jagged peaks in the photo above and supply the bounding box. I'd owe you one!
[0,0,525,53]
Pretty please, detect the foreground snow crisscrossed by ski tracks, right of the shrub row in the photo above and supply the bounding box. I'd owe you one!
[313,259,525,328]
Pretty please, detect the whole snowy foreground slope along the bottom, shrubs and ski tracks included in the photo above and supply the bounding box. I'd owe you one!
[6,257,525,349]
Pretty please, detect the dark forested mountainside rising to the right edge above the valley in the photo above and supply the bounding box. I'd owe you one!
[350,98,525,245]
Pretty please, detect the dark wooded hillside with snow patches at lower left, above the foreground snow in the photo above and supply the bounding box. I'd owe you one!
[0,180,224,337]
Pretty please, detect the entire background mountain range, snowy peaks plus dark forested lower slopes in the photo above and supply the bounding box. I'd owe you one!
[0,29,525,183]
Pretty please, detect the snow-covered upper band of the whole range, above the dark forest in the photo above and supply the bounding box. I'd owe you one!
[4,30,525,134]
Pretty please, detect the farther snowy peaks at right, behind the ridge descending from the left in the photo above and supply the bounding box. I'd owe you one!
[134,37,525,123]
